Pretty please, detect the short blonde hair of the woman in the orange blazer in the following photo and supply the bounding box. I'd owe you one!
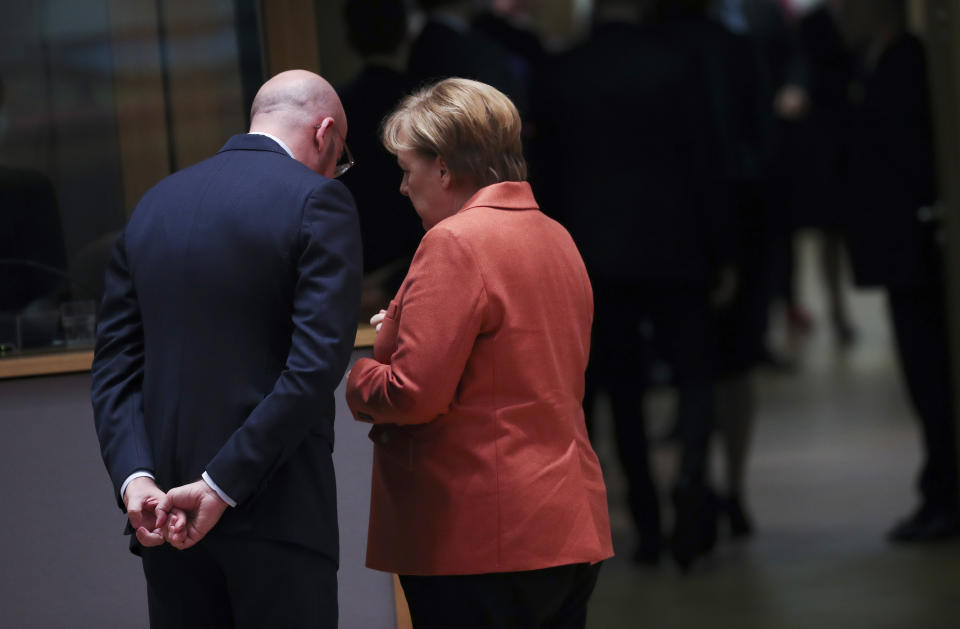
[382,78,527,187]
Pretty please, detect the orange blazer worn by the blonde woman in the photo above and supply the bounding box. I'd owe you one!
[347,182,613,575]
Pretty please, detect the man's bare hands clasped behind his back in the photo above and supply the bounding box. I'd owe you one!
[123,477,227,550]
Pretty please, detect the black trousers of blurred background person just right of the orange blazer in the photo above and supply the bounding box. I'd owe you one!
[584,282,716,546]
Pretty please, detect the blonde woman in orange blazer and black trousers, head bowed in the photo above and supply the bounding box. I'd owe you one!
[347,79,613,629]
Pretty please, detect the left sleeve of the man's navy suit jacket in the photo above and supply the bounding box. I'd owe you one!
[90,228,153,509]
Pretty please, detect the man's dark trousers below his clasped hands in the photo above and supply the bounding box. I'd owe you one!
[141,536,337,629]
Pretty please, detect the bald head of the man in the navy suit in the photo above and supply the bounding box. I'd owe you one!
[250,70,347,174]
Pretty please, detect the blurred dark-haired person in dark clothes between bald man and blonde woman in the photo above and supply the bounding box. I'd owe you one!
[337,0,423,302]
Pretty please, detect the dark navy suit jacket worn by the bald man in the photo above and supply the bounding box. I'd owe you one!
[92,135,362,559]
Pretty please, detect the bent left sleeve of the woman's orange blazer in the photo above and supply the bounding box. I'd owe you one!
[347,227,488,424]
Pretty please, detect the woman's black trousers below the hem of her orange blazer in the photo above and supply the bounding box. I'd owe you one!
[400,563,600,629]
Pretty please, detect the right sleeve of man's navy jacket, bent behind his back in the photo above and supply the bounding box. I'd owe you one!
[206,180,363,504]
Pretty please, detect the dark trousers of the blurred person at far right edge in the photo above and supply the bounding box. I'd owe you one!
[888,282,958,514]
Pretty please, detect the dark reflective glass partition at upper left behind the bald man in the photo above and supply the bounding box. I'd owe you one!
[0,0,263,359]
